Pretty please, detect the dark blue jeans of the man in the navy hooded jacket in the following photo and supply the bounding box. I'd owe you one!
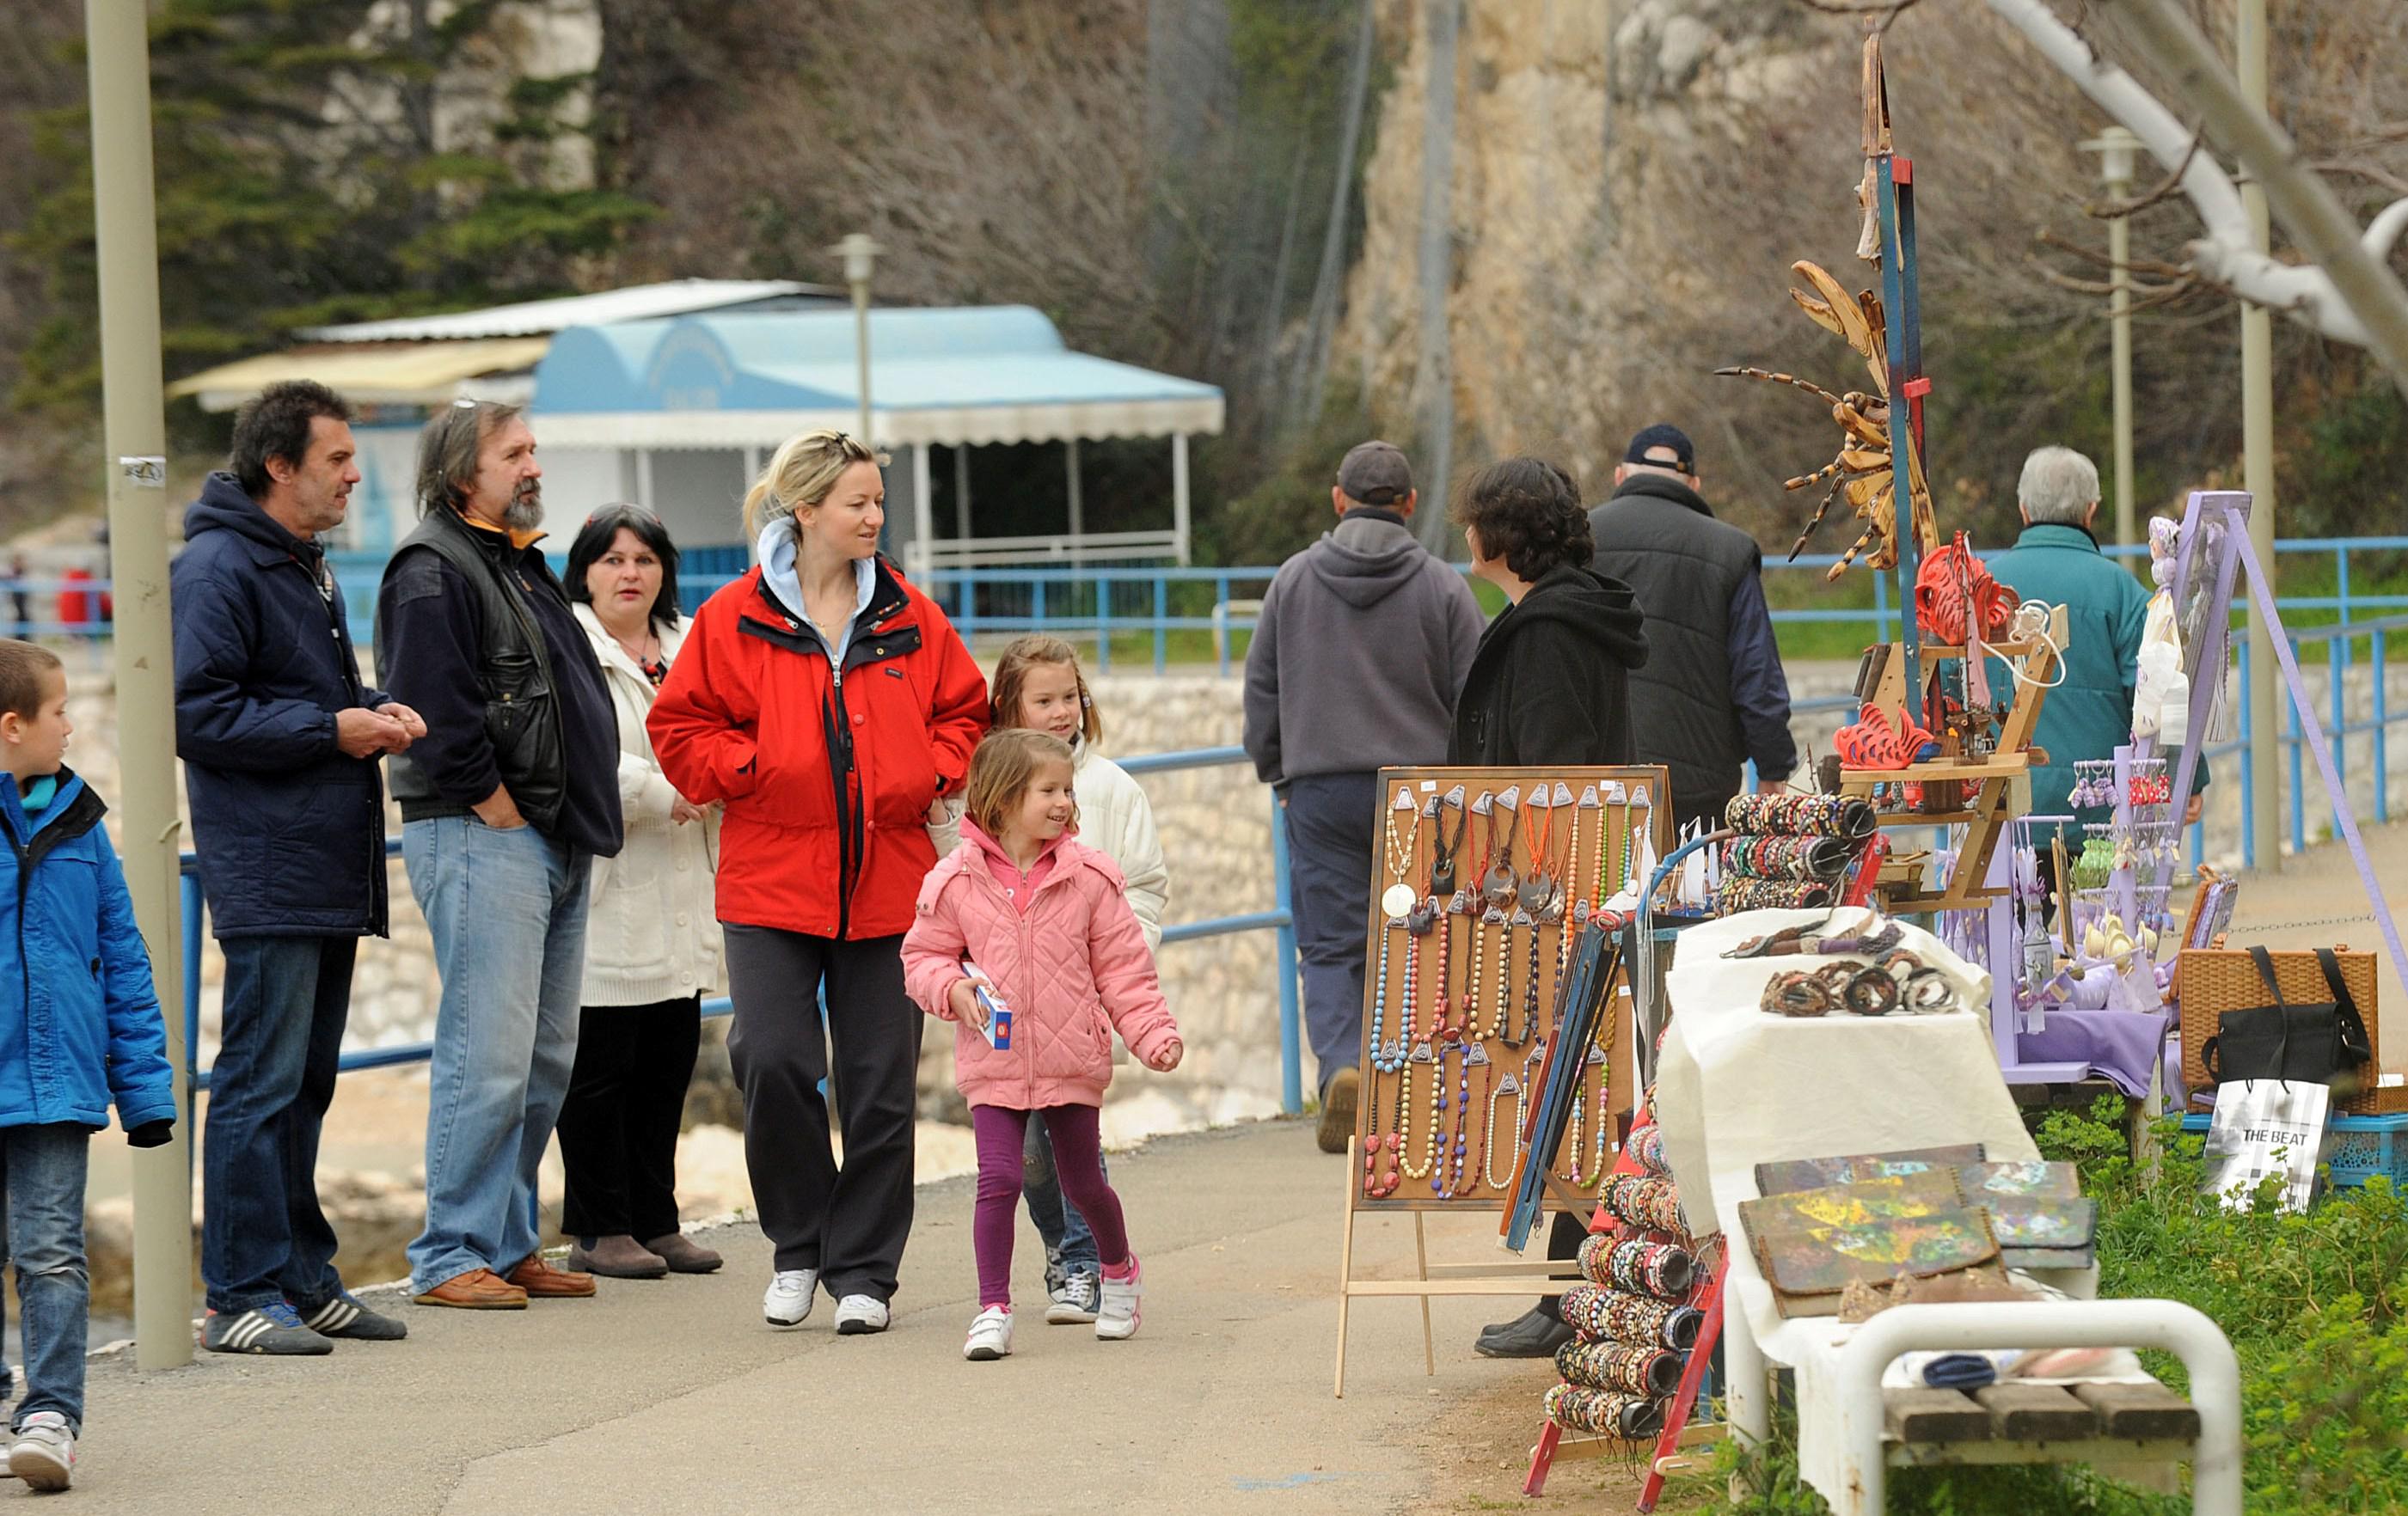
[199,936,358,1317]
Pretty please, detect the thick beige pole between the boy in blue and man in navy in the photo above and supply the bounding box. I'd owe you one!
[84,0,193,1369]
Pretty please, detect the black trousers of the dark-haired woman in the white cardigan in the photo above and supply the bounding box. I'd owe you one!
[554,993,703,1242]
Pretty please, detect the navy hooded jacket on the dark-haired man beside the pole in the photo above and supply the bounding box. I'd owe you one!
[168,472,393,938]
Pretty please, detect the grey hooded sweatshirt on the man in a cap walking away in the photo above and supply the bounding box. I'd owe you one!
[1245,517,1481,785]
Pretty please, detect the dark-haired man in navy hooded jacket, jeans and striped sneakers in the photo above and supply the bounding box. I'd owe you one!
[171,380,426,1353]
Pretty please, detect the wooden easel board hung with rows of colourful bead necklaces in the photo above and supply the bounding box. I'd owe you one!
[1334,767,1671,1398]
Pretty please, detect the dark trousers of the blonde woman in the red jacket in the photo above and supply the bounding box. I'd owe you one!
[727,926,927,1299]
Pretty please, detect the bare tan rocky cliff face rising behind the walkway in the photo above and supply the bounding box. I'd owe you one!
[1337,0,2148,551]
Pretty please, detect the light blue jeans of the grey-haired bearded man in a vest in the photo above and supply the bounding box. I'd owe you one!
[402,816,592,1293]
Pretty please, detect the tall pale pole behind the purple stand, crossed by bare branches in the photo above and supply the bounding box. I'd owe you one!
[2234,0,2282,871]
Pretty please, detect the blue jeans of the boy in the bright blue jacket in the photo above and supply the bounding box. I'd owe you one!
[0,1124,91,1432]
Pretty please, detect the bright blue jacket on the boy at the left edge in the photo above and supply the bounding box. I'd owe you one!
[0,770,175,1131]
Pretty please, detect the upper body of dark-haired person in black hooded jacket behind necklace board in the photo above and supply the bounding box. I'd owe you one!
[1447,457,1647,767]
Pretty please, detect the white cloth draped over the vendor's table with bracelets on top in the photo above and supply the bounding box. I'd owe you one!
[1657,909,2039,1495]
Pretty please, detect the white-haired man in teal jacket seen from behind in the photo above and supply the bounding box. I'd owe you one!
[1989,448,2209,852]
